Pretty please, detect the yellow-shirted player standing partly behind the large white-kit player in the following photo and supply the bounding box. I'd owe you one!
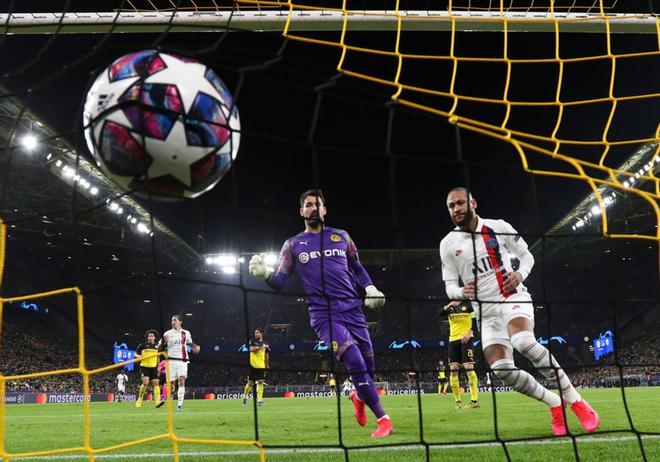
[442,301,479,409]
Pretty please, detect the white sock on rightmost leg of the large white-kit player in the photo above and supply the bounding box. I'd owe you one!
[511,331,582,404]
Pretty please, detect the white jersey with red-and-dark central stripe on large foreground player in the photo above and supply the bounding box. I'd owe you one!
[440,217,534,303]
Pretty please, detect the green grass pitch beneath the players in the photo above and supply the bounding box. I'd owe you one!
[5,388,660,462]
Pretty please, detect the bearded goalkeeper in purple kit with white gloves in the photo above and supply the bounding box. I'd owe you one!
[249,189,392,438]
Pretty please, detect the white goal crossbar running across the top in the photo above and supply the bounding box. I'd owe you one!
[0,10,660,34]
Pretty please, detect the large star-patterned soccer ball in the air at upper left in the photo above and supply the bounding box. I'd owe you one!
[83,50,241,199]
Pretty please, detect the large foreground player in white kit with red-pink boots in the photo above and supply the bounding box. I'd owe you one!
[440,188,600,436]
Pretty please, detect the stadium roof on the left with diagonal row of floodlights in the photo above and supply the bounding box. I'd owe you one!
[0,87,201,268]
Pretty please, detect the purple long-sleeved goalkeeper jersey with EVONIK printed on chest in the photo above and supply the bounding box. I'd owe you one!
[266,228,372,313]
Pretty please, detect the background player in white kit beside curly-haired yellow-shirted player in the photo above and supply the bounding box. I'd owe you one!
[160,314,199,412]
